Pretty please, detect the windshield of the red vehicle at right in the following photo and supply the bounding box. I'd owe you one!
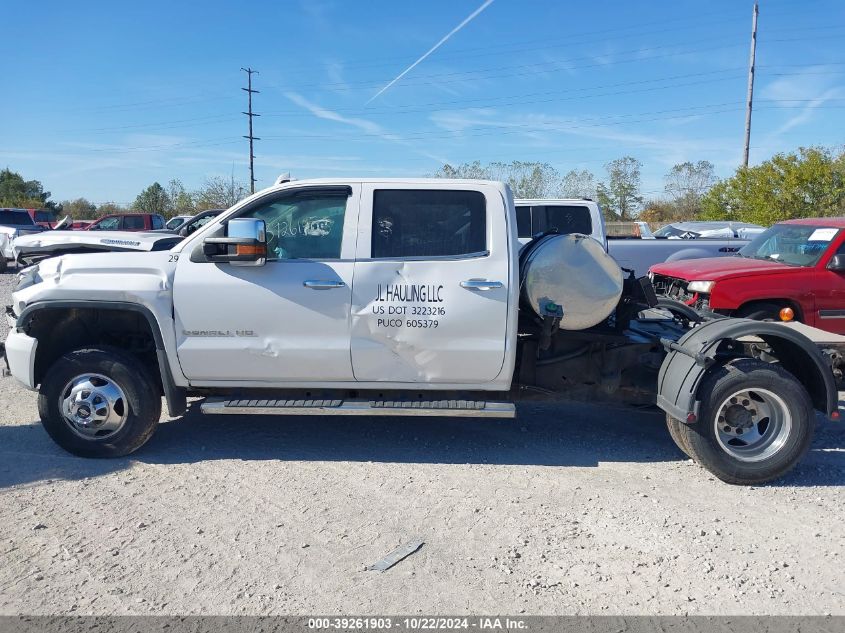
[739,224,839,266]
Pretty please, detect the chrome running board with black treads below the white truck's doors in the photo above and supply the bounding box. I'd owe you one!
[200,398,516,418]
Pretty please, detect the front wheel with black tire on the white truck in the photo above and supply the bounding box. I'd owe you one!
[38,347,161,457]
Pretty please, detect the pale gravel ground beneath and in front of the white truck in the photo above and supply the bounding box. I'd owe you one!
[0,264,845,614]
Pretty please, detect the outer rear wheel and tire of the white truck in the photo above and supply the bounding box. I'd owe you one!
[679,359,815,485]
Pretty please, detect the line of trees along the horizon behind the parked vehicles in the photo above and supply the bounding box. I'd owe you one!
[0,147,845,226]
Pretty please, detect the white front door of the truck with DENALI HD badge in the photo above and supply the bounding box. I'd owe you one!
[174,185,360,386]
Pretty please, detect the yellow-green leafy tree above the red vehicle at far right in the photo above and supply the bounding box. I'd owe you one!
[702,147,845,226]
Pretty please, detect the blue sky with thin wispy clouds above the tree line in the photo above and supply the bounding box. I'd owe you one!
[0,0,845,204]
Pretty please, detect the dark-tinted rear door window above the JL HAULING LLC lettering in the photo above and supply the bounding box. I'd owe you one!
[372,189,487,258]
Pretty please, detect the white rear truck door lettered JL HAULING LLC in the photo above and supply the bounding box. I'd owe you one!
[351,183,508,384]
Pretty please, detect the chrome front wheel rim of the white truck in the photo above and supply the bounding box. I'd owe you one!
[59,374,129,440]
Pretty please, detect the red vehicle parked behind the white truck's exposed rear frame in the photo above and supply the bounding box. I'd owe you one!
[650,218,845,334]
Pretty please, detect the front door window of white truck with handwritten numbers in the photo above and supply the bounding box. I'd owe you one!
[240,192,348,260]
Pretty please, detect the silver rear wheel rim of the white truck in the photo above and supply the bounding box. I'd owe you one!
[714,389,792,462]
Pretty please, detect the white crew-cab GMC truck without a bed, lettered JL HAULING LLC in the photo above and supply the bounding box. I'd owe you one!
[3,179,838,484]
